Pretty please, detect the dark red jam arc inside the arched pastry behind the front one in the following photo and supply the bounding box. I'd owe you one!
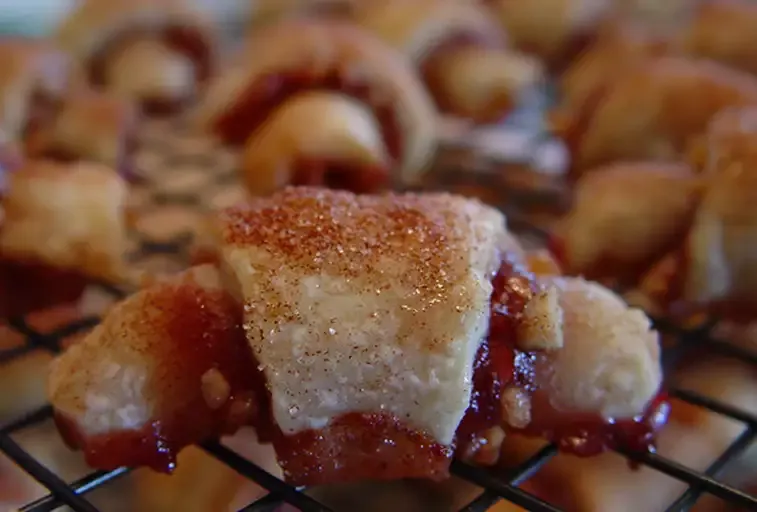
[210,69,403,160]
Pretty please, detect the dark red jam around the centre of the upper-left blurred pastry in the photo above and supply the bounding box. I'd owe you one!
[89,25,213,115]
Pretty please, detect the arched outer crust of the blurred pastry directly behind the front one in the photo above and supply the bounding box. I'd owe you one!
[197,20,437,192]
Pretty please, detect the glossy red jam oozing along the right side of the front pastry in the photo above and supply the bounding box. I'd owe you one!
[457,254,669,456]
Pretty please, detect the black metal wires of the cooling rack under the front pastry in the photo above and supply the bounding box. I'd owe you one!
[0,149,757,512]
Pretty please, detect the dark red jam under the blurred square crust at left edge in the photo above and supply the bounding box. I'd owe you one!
[0,258,89,318]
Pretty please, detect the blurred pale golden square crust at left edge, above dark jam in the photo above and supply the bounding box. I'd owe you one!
[0,161,127,281]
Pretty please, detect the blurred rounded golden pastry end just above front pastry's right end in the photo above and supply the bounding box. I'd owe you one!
[554,162,704,285]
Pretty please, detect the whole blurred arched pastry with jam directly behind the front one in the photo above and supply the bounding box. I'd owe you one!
[197,20,438,194]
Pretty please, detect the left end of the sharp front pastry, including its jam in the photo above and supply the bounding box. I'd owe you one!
[48,266,257,469]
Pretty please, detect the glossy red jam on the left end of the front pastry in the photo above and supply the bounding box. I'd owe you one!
[56,285,268,473]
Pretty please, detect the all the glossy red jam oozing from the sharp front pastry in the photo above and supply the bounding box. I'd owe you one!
[57,253,667,485]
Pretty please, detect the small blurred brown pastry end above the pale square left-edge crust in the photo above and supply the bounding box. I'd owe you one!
[29,90,139,176]
